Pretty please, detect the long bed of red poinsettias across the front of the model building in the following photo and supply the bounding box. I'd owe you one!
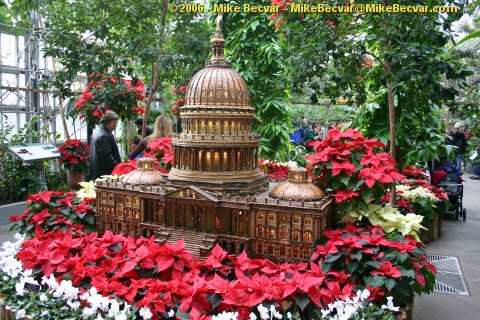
[17,228,354,319]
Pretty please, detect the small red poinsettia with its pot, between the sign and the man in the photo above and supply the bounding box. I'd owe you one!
[58,139,90,188]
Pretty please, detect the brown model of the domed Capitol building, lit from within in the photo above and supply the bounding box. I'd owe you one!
[95,15,333,261]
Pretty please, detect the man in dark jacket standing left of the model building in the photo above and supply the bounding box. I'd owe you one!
[90,110,122,181]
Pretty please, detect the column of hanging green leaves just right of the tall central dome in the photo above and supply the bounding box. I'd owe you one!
[217,0,292,161]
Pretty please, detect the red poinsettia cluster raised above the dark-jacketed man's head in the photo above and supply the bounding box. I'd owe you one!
[74,74,146,123]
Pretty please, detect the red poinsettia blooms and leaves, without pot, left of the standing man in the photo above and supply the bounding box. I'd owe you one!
[58,139,90,171]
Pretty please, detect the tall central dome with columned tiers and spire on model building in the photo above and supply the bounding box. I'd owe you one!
[166,14,268,195]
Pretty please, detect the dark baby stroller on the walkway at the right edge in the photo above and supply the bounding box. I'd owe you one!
[434,171,467,221]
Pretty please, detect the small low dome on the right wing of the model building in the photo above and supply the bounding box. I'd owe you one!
[270,168,325,201]
